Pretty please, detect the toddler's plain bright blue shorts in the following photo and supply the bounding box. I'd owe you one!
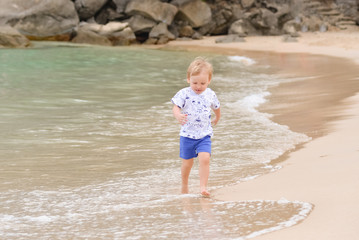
[180,136,212,159]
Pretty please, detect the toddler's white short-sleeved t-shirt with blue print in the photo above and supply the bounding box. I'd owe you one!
[172,87,220,139]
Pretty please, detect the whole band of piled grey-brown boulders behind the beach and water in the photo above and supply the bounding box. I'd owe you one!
[0,0,359,47]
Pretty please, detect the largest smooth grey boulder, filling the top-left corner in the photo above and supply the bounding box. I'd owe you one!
[0,0,79,40]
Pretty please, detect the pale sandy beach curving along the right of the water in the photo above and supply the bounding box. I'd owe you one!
[165,31,359,240]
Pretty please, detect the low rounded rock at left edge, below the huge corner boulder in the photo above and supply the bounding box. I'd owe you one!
[0,26,30,48]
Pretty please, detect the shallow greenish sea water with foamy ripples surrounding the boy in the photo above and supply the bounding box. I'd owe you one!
[0,43,311,239]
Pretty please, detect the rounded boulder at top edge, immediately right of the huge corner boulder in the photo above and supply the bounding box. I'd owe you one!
[75,0,107,20]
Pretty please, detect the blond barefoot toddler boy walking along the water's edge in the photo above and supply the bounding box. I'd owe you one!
[172,57,221,197]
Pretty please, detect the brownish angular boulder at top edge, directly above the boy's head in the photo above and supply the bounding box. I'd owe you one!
[173,0,212,28]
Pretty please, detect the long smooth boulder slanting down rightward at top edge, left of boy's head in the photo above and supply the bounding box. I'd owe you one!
[125,0,177,25]
